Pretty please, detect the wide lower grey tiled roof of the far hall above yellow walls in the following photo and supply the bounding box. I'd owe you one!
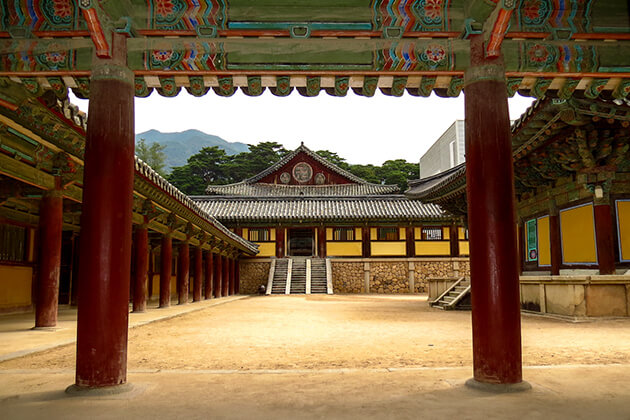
[192,195,450,223]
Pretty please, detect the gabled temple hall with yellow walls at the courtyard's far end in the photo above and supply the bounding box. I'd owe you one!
[191,144,468,293]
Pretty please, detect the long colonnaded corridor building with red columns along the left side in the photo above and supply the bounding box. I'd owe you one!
[0,80,258,316]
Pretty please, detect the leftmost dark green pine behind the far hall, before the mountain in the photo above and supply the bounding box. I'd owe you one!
[168,146,233,195]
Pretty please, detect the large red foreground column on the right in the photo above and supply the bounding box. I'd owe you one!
[464,35,522,386]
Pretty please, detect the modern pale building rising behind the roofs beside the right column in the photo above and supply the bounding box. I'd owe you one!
[420,120,466,178]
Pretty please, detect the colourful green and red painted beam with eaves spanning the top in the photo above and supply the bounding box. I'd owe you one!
[0,0,630,99]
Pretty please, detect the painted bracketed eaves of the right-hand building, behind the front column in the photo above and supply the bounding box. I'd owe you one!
[405,97,630,215]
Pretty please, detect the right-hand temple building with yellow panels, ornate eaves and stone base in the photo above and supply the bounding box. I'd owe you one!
[406,97,630,316]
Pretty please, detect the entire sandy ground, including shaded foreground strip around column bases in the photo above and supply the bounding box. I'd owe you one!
[0,295,630,420]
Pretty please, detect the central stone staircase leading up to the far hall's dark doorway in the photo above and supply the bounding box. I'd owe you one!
[267,257,332,295]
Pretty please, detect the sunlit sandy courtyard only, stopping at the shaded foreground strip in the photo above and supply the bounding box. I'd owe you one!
[0,295,630,370]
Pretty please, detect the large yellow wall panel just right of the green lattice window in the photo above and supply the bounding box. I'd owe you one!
[560,204,597,264]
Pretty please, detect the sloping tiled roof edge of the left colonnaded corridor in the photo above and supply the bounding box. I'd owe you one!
[134,156,258,254]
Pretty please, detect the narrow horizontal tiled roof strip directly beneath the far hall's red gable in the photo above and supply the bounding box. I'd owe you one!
[206,182,398,197]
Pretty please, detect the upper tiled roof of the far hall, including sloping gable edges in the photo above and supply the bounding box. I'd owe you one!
[206,143,399,197]
